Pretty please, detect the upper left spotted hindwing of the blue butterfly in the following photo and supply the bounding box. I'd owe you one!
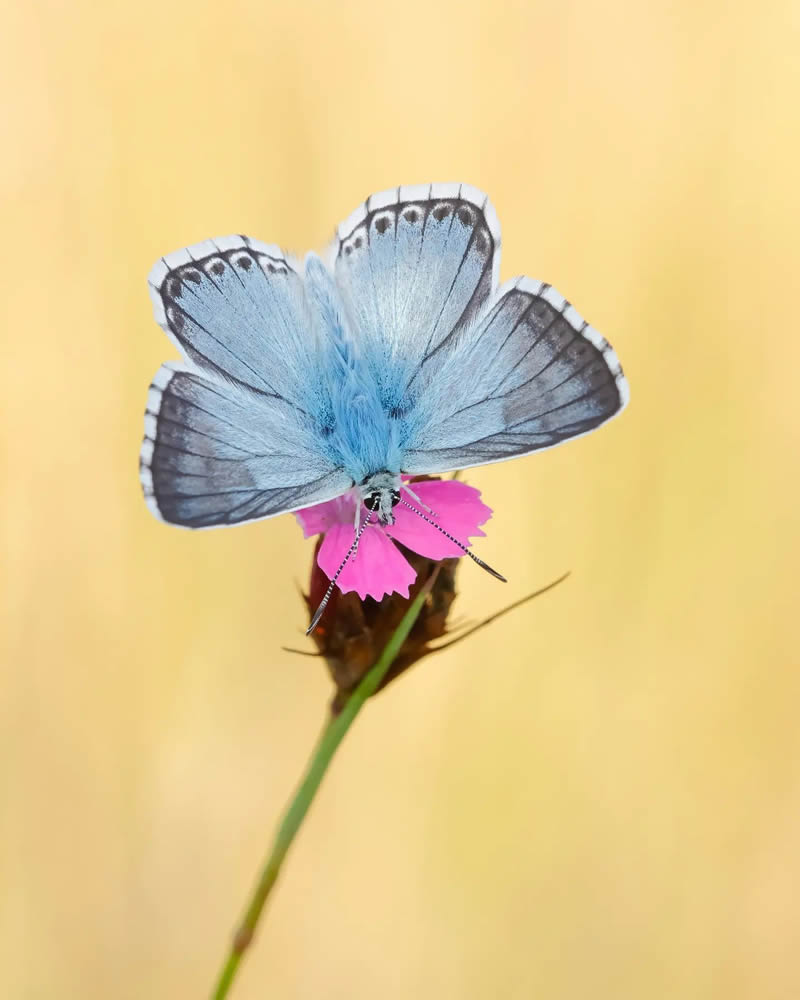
[148,236,313,405]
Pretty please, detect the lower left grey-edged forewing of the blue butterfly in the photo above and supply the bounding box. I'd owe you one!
[140,364,352,528]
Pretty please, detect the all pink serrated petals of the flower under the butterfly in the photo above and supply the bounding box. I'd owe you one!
[295,479,492,601]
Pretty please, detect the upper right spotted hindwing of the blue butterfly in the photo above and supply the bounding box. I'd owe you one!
[333,184,500,404]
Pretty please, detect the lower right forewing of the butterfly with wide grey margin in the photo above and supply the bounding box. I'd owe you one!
[403,278,628,474]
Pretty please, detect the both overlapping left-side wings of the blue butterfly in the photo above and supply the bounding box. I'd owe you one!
[140,236,352,528]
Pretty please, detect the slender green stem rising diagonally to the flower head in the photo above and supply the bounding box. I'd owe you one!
[211,568,438,1000]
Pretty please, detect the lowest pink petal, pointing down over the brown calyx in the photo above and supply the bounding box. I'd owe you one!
[317,521,417,601]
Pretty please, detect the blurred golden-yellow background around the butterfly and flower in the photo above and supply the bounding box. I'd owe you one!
[0,0,800,1000]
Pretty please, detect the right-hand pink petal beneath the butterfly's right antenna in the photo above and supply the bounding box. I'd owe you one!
[386,479,492,559]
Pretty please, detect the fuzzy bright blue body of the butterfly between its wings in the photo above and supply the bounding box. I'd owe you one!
[306,254,403,483]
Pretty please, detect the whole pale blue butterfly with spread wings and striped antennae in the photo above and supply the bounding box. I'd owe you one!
[140,184,628,627]
